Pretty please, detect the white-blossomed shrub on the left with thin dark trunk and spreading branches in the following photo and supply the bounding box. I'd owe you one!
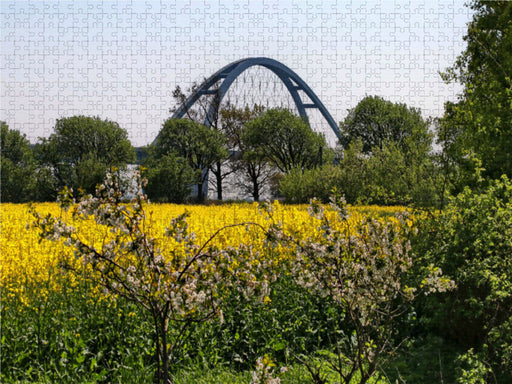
[32,172,278,383]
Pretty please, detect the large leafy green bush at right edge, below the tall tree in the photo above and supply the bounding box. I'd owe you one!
[414,176,512,383]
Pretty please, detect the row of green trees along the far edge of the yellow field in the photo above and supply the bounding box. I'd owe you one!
[1,97,433,203]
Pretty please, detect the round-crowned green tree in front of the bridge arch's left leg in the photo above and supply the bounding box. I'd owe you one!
[152,119,228,201]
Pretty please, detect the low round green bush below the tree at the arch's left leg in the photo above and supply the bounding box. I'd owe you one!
[144,153,196,203]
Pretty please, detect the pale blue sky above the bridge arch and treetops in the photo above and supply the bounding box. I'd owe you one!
[0,0,472,146]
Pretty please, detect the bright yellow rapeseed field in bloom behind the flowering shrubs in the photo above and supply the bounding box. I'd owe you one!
[0,203,403,305]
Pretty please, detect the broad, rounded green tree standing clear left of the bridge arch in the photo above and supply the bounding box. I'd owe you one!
[37,116,135,193]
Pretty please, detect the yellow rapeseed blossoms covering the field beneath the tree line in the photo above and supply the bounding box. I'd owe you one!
[0,202,404,306]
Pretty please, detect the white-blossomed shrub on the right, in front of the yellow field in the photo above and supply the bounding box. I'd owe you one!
[292,198,453,384]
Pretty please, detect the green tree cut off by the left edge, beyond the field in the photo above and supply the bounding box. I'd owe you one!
[0,121,37,203]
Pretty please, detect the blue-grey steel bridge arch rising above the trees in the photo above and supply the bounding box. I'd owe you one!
[171,57,341,139]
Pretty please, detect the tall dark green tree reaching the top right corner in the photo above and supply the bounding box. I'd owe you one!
[438,0,512,186]
